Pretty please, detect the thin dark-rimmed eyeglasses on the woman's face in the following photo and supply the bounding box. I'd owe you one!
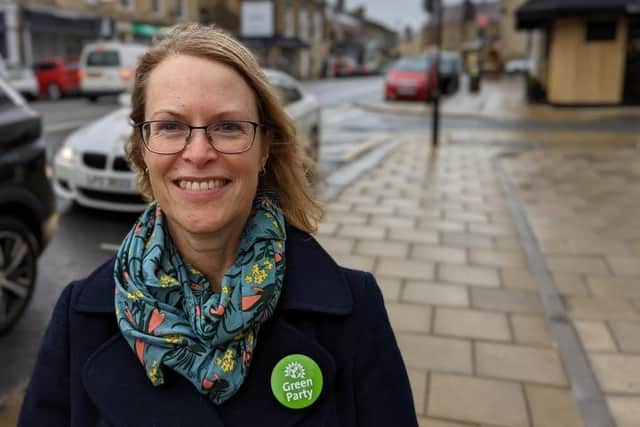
[134,120,264,154]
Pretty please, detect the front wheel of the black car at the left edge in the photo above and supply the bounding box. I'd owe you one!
[0,217,37,334]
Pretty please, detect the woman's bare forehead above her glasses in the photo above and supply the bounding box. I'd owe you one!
[145,55,257,119]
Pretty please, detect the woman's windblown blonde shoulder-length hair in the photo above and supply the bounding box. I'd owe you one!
[126,24,322,233]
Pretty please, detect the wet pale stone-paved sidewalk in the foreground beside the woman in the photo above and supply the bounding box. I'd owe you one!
[318,134,640,427]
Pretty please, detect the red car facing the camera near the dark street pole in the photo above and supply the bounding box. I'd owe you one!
[384,55,437,101]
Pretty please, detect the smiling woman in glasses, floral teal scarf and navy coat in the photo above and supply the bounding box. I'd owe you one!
[19,25,416,427]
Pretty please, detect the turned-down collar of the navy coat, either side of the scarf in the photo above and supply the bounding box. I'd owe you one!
[71,226,353,315]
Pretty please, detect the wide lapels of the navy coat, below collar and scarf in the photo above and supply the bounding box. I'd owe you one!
[83,318,336,427]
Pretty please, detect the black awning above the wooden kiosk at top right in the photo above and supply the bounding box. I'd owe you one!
[516,0,640,30]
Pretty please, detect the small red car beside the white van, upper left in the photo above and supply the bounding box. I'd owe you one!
[33,58,80,99]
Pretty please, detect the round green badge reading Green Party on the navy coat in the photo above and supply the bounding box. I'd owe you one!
[271,354,322,409]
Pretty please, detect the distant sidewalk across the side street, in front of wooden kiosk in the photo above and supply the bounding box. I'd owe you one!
[356,76,640,122]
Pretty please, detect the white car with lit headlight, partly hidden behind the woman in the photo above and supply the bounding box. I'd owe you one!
[53,70,320,212]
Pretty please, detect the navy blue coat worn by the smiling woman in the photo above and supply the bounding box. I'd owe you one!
[18,227,417,427]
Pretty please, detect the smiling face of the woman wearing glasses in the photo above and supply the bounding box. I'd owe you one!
[144,55,268,241]
